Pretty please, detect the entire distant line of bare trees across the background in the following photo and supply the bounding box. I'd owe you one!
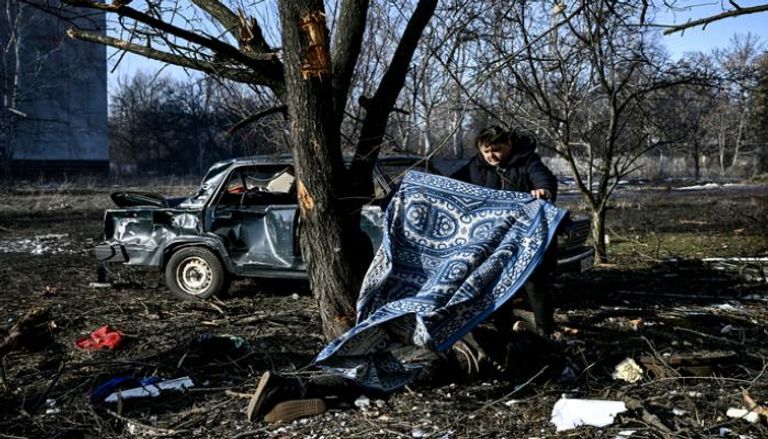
[110,19,768,187]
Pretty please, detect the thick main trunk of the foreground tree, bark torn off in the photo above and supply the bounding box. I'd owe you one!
[280,0,361,339]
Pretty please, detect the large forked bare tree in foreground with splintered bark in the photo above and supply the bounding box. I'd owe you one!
[36,0,437,337]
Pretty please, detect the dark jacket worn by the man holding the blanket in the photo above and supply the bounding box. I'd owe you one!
[451,134,557,201]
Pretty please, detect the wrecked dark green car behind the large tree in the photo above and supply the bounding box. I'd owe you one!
[95,156,594,299]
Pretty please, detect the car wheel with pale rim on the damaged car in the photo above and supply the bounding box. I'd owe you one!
[165,247,230,300]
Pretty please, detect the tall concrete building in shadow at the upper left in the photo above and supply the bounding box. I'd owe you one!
[0,0,109,178]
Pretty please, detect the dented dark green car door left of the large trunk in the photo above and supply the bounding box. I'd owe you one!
[210,164,303,275]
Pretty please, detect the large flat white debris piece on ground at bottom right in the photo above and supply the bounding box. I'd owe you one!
[551,397,627,431]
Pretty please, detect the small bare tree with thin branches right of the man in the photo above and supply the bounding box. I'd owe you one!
[474,1,690,261]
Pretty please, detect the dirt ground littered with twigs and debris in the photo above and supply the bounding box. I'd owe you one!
[0,186,768,439]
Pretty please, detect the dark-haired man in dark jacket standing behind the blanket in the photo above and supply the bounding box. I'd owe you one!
[451,126,557,337]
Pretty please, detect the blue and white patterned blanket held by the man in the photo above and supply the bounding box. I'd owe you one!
[315,172,566,391]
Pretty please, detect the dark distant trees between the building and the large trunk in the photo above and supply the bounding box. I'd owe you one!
[109,73,284,177]
